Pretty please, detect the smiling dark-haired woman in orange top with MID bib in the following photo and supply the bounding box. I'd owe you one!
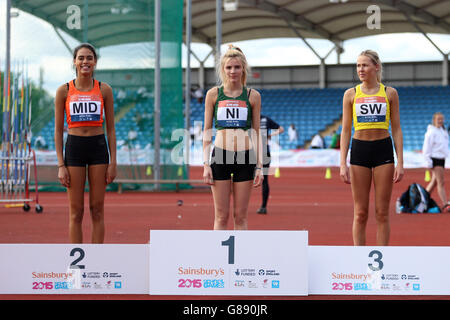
[55,43,117,243]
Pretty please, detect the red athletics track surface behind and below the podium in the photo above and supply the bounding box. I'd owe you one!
[0,167,450,300]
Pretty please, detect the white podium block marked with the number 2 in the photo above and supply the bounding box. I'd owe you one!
[0,244,149,294]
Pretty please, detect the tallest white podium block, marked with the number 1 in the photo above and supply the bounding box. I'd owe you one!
[149,230,308,296]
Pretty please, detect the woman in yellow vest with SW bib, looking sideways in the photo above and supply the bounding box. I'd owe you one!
[340,50,404,246]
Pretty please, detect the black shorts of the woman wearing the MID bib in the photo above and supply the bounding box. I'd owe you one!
[64,134,109,167]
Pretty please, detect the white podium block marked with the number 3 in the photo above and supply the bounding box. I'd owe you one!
[309,246,450,295]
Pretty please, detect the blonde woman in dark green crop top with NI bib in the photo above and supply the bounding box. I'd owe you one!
[203,46,264,230]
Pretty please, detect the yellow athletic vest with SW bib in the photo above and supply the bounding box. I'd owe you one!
[353,83,391,130]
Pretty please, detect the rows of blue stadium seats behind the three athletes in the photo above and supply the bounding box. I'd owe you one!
[32,86,450,151]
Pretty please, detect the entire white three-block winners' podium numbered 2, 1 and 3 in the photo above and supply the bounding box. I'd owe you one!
[0,230,450,296]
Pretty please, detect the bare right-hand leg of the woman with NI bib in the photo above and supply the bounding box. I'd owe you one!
[233,180,253,230]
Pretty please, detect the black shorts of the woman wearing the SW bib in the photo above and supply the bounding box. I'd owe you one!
[350,137,394,168]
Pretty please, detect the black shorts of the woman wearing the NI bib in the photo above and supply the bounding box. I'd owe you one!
[211,147,256,182]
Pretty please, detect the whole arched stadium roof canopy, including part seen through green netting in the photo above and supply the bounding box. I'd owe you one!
[8,0,450,47]
